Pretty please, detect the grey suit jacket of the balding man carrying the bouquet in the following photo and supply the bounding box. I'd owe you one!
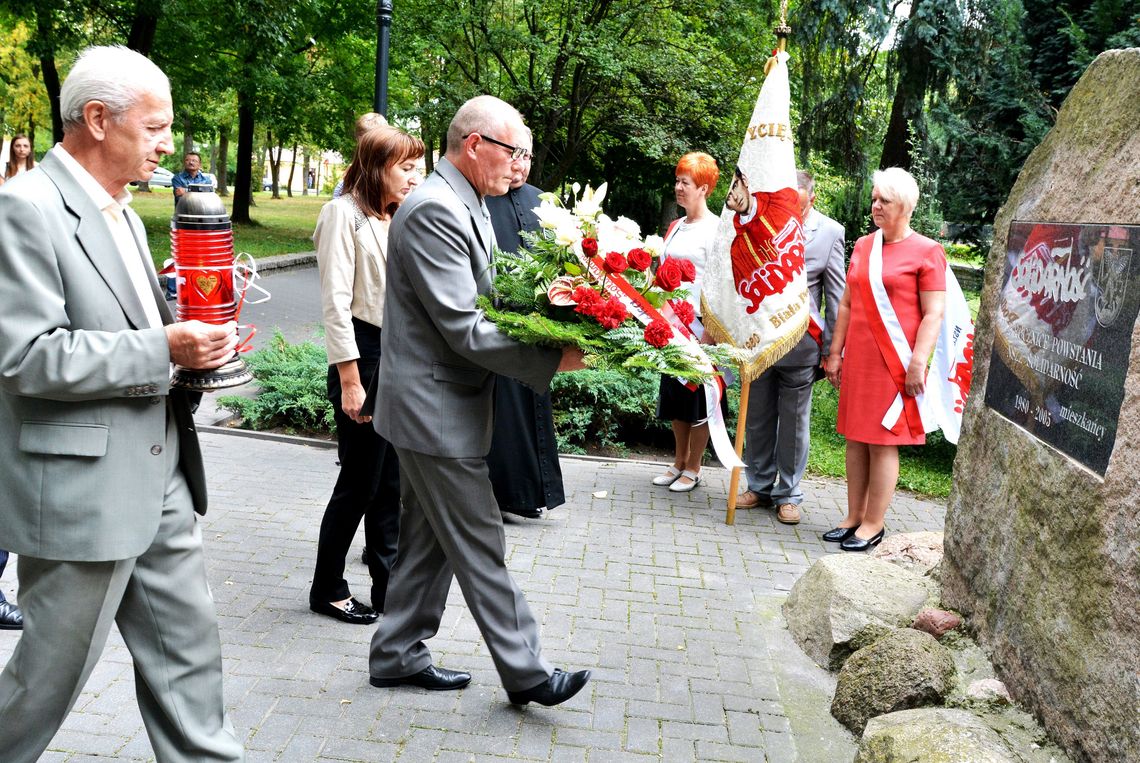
[373,153,562,451]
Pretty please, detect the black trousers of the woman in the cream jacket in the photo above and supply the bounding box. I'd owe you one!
[309,318,400,611]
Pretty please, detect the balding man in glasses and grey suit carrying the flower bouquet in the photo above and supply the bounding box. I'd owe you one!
[369,96,589,705]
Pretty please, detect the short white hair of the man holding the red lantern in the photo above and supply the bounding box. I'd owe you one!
[59,46,170,132]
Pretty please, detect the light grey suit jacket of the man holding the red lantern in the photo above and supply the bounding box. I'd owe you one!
[0,152,206,561]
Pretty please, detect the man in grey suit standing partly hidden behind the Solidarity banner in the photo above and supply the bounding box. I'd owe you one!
[736,172,846,525]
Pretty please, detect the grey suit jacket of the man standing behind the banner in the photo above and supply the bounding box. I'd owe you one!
[776,208,847,367]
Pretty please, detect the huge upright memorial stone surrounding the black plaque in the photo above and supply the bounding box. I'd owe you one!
[943,49,1140,761]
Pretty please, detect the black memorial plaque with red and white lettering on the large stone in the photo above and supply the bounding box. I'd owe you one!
[986,216,1140,477]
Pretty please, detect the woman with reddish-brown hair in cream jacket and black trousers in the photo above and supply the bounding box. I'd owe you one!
[309,127,424,625]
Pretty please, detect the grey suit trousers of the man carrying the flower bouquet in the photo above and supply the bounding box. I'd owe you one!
[368,448,553,691]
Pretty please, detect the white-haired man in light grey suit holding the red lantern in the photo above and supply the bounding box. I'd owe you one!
[0,48,243,763]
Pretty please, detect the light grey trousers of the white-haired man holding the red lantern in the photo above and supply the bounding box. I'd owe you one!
[0,417,244,763]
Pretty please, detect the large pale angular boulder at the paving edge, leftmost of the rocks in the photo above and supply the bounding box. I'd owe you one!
[783,554,933,669]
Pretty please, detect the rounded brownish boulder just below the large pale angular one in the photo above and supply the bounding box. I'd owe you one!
[831,628,954,734]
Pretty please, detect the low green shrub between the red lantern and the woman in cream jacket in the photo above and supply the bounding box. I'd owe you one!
[218,332,334,432]
